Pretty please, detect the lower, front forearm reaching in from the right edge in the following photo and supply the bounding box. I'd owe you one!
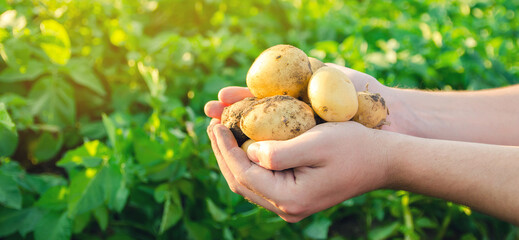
[389,136,519,225]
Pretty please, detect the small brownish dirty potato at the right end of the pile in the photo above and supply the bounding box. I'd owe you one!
[353,91,389,129]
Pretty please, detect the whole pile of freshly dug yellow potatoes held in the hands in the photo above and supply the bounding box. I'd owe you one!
[222,45,389,150]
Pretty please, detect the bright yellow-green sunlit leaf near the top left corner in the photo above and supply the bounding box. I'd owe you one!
[40,20,70,65]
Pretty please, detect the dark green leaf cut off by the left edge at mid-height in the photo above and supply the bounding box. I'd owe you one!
[0,102,18,157]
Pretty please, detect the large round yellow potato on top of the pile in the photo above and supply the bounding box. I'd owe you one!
[246,45,312,98]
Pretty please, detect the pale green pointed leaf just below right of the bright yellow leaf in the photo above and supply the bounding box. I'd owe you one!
[67,58,106,96]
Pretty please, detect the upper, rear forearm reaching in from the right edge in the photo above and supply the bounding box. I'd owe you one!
[384,85,519,146]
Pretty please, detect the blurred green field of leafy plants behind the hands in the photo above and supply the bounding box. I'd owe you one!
[0,0,519,240]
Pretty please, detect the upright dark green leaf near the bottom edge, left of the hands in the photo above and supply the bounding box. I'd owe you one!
[159,189,183,234]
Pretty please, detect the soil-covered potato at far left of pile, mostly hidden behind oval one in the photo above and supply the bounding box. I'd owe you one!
[222,98,257,145]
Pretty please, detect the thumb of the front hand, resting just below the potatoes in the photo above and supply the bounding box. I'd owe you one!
[247,138,321,171]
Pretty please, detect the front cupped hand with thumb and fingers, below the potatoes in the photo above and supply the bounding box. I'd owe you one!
[208,119,389,222]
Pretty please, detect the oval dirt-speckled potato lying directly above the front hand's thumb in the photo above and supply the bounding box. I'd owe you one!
[240,95,315,141]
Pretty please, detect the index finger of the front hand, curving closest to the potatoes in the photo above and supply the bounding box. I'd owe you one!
[214,124,285,202]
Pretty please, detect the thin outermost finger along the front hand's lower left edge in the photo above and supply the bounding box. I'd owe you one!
[208,121,294,218]
